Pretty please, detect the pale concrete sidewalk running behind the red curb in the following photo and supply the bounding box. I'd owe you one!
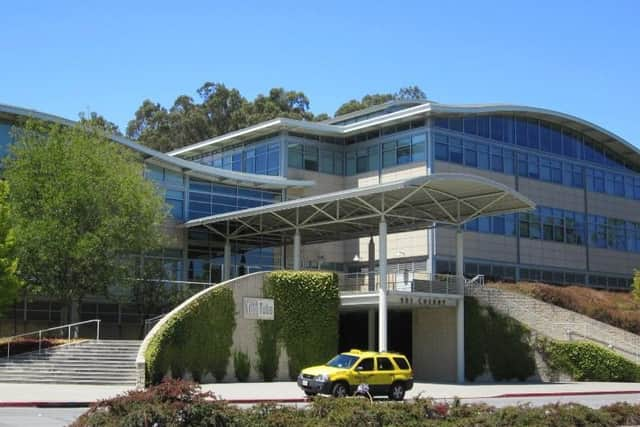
[0,382,640,407]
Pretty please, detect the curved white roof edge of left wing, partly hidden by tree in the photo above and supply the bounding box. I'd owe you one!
[0,104,315,189]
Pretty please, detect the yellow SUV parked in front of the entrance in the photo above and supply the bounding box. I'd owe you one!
[298,350,413,400]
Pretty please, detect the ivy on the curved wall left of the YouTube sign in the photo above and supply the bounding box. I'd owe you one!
[145,287,236,384]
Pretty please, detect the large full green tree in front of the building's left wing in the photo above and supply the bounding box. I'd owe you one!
[5,120,168,320]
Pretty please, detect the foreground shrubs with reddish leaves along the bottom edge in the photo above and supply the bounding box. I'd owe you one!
[72,381,640,427]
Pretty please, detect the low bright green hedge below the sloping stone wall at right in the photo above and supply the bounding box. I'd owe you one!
[536,339,640,382]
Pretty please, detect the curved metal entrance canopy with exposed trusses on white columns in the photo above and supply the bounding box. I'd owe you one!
[184,173,535,246]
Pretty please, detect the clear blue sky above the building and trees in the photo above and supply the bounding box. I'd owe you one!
[0,0,640,145]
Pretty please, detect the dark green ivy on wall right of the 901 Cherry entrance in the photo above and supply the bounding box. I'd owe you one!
[464,297,535,381]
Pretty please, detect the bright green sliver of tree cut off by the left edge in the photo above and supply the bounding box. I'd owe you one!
[0,180,22,310]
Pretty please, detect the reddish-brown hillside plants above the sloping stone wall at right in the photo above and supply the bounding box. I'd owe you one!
[488,282,640,334]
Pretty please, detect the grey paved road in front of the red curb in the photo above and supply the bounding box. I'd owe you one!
[0,393,640,427]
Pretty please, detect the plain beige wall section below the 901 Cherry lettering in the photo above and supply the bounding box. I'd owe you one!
[412,307,457,382]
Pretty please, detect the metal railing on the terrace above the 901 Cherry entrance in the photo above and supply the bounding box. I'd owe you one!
[338,270,461,295]
